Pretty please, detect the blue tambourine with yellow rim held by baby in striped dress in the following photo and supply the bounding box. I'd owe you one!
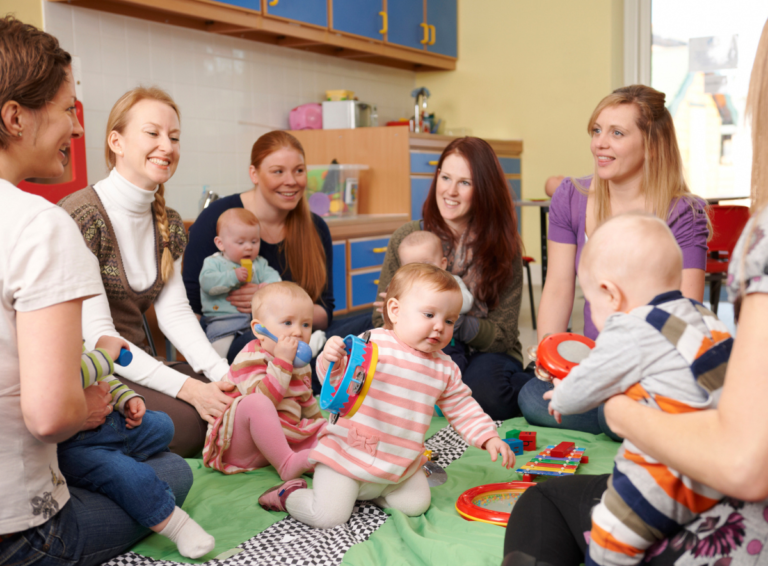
[320,332,379,424]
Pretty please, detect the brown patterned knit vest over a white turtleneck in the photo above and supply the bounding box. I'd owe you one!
[59,187,187,353]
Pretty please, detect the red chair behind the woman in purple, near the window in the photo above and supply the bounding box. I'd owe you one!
[705,204,749,314]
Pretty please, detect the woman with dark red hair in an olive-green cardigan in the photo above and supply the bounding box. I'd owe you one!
[374,137,533,419]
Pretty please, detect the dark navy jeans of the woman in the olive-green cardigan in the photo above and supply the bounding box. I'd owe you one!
[462,352,535,421]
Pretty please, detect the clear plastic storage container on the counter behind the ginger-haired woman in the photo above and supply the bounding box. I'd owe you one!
[307,165,368,217]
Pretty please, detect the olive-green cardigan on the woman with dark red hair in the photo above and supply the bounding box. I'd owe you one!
[373,220,523,364]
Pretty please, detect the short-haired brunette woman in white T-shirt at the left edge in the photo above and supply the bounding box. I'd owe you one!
[0,17,192,566]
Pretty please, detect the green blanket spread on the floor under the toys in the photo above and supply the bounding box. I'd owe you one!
[133,417,619,566]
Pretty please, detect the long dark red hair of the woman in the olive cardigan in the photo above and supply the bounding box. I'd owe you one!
[422,137,523,309]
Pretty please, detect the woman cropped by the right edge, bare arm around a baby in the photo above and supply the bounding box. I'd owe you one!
[503,18,768,566]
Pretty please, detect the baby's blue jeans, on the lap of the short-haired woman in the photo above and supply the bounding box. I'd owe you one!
[58,411,176,527]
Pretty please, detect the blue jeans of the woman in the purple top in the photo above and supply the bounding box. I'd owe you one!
[518,379,622,442]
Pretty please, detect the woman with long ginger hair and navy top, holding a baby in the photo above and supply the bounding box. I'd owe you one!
[184,130,335,361]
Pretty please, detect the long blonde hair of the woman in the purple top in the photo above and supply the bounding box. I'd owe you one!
[584,85,712,235]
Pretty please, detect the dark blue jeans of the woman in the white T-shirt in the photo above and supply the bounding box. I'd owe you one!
[0,452,192,566]
